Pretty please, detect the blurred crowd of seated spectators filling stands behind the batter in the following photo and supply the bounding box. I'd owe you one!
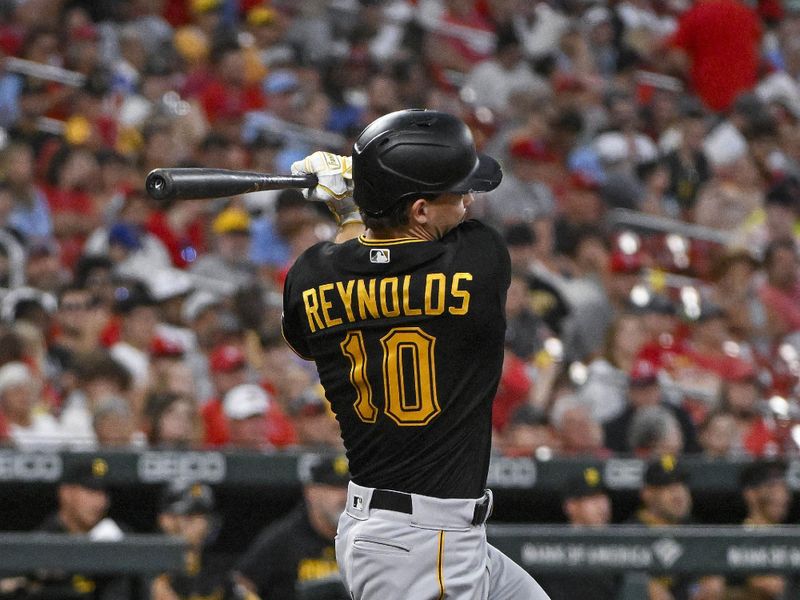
[0,0,800,466]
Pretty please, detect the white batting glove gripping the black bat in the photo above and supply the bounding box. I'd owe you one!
[292,152,361,225]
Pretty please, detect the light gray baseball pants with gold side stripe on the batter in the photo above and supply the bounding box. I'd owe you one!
[336,482,549,600]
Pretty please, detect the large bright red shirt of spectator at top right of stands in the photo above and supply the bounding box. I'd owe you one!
[670,0,761,111]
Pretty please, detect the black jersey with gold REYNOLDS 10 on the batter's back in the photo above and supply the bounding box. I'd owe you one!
[283,221,511,498]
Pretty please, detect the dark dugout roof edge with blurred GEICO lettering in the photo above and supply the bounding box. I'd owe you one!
[0,449,800,493]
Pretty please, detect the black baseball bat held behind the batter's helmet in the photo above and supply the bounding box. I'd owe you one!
[144,167,317,202]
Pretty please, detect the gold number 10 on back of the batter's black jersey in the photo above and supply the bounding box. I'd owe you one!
[340,327,441,427]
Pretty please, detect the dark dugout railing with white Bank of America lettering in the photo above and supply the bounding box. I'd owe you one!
[488,525,800,600]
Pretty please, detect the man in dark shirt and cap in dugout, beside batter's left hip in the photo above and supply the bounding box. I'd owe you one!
[237,455,350,600]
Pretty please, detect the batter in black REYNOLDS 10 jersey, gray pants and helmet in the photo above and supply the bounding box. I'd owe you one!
[283,110,548,600]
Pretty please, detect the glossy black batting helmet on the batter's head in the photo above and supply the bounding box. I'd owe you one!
[353,109,503,216]
